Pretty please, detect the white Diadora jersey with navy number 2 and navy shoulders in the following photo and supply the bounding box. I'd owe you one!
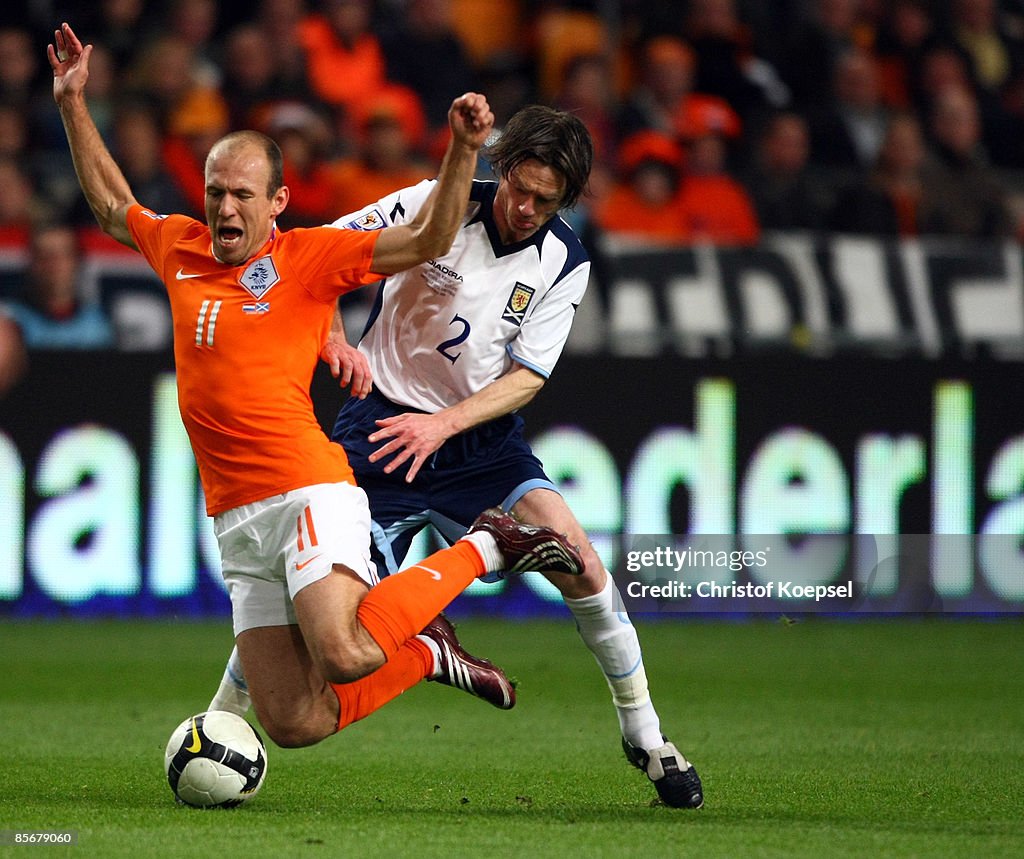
[332,180,590,413]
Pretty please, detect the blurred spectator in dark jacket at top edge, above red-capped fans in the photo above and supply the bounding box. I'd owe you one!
[684,0,790,124]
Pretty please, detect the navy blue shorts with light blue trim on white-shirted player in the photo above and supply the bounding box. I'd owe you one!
[331,389,557,575]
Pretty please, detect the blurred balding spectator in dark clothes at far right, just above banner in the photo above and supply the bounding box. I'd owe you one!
[921,88,1012,238]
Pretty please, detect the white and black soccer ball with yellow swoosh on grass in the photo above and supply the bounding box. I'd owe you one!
[164,710,266,808]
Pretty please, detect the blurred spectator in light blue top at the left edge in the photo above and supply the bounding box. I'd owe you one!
[6,224,114,350]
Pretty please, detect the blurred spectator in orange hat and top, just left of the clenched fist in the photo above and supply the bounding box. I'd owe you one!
[331,84,437,218]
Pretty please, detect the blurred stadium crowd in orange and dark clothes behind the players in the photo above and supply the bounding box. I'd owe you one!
[0,0,1024,376]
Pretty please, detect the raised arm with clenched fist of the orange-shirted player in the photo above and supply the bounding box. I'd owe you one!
[373,92,495,274]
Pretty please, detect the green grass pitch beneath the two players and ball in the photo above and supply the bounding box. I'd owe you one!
[0,617,1024,859]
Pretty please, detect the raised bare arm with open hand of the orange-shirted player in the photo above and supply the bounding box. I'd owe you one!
[46,24,135,248]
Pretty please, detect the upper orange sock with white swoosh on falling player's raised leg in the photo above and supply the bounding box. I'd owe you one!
[356,541,486,659]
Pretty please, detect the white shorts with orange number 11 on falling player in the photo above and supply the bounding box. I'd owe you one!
[213,483,380,636]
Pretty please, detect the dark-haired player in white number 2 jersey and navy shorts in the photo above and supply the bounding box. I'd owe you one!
[211,105,703,808]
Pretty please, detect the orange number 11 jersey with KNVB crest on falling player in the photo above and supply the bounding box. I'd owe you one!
[128,205,380,516]
